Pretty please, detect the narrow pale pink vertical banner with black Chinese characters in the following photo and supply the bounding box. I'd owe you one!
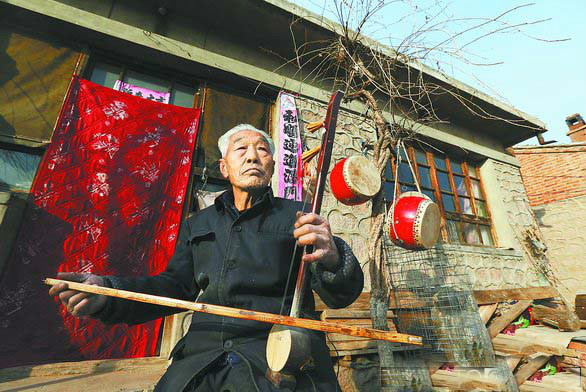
[277,93,301,201]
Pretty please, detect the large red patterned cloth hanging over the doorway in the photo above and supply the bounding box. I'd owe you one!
[0,78,200,368]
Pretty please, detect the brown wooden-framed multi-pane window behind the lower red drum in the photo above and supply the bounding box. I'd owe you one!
[384,147,495,246]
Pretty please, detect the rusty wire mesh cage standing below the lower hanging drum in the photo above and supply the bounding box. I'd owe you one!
[385,238,496,367]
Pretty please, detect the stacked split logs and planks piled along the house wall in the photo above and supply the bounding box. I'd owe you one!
[316,287,586,392]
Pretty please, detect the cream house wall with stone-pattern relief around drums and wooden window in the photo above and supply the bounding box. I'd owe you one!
[296,98,548,291]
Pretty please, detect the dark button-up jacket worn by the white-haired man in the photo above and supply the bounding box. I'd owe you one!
[99,188,363,391]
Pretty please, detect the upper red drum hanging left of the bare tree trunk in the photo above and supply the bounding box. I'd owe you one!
[330,155,381,206]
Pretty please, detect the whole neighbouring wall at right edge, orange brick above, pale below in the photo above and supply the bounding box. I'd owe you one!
[514,143,586,303]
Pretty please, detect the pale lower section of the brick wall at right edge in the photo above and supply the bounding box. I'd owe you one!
[533,196,586,302]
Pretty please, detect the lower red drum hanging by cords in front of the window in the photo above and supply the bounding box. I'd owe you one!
[388,192,441,250]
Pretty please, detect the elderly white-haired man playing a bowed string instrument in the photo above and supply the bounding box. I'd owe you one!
[49,124,363,392]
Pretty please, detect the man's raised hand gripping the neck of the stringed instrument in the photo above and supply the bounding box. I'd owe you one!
[293,212,340,271]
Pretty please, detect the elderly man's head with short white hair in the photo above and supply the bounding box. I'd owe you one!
[220,131,275,191]
